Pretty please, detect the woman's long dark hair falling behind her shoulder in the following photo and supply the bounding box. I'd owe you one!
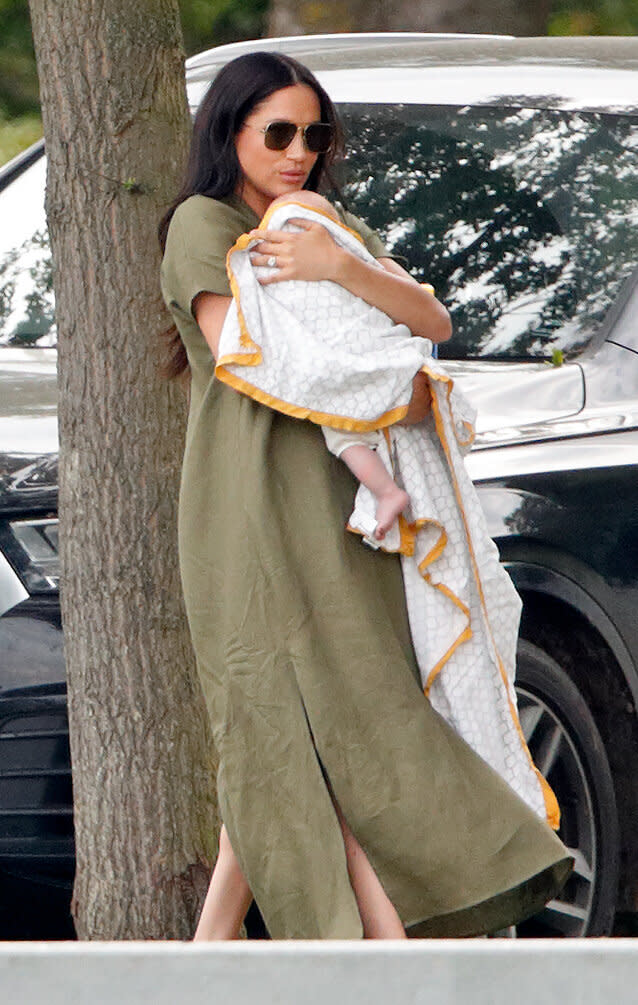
[158,52,343,378]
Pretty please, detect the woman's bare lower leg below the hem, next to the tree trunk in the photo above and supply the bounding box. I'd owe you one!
[193,825,252,942]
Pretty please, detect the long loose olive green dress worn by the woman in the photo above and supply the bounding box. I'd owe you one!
[162,195,572,939]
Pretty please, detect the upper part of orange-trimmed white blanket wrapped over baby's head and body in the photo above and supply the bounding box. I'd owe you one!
[215,204,431,430]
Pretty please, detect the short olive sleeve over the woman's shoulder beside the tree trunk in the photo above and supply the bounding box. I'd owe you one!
[161,195,246,318]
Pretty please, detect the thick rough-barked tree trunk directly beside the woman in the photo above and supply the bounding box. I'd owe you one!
[30,0,218,939]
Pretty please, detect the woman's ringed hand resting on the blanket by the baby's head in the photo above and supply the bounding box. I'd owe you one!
[248,219,339,286]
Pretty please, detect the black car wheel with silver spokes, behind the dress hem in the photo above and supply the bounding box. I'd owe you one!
[515,639,619,938]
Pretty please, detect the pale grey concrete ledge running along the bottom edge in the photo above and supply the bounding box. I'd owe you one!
[0,939,638,1005]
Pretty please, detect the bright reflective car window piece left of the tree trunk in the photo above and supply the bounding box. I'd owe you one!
[0,157,55,348]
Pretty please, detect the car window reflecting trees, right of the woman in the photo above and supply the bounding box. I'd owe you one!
[340,104,638,359]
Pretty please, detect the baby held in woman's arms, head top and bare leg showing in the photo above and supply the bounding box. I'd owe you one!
[265,190,410,548]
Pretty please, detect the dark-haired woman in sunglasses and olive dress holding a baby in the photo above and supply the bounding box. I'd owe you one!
[161,53,572,939]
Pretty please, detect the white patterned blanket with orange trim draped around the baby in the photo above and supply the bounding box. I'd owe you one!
[215,204,559,827]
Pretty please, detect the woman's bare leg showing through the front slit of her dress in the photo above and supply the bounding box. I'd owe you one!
[333,797,407,939]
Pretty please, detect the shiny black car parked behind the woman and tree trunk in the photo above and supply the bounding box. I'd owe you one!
[0,34,638,937]
